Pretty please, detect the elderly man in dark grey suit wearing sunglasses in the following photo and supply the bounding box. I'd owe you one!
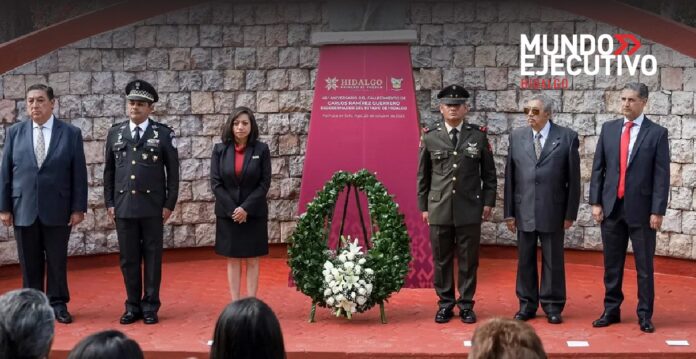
[504,95,580,324]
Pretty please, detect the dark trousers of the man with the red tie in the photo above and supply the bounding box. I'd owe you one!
[602,200,657,319]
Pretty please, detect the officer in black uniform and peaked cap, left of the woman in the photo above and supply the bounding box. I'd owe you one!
[104,80,179,324]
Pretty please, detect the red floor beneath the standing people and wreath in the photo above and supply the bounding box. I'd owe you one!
[0,248,696,358]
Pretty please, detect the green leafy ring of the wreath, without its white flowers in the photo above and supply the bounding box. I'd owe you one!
[288,169,411,323]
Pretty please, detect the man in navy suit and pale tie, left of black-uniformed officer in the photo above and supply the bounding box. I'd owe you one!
[0,84,87,324]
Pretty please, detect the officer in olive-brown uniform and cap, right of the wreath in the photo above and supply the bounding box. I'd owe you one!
[418,85,497,323]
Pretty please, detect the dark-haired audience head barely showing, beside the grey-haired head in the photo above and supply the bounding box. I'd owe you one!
[68,330,144,359]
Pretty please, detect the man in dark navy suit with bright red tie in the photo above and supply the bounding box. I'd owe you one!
[590,83,670,333]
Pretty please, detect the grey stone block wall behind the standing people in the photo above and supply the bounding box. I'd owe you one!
[0,1,696,264]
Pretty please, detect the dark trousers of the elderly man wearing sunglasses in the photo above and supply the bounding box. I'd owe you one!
[516,229,566,314]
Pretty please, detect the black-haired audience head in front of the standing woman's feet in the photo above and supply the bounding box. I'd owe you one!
[210,297,285,359]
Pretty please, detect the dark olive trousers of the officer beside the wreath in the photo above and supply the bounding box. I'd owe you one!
[430,224,481,310]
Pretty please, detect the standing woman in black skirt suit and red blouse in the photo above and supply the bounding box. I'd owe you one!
[210,107,271,301]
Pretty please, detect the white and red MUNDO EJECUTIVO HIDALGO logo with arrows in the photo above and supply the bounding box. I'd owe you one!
[520,34,657,89]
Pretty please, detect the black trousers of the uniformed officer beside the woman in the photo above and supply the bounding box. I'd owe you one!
[116,217,163,313]
